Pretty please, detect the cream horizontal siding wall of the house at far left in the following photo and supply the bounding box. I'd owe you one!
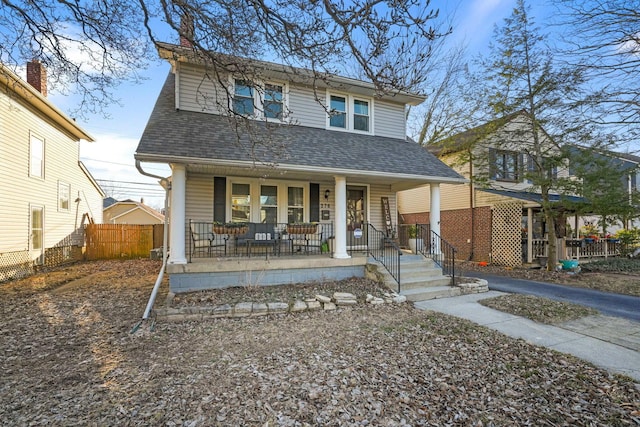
[0,88,102,258]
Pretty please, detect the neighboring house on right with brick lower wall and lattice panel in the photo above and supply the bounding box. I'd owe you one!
[398,112,580,266]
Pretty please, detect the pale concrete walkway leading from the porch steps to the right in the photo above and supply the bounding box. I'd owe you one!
[415,291,640,383]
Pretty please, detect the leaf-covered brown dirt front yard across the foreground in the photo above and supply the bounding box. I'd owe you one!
[0,260,640,426]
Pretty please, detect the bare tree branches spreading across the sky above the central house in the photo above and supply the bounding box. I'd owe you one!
[0,0,449,118]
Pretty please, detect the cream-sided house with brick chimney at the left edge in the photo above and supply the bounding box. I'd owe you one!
[0,62,105,280]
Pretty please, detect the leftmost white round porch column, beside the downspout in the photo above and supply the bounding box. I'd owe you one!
[169,163,187,264]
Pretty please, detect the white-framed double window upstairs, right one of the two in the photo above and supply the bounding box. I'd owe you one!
[328,94,371,133]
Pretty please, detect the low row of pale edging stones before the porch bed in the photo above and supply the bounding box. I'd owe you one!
[154,292,407,321]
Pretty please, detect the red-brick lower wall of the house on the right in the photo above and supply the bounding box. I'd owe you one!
[401,207,491,261]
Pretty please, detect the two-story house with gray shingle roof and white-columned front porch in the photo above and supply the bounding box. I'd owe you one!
[135,43,464,291]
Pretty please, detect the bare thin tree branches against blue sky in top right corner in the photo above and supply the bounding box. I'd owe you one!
[557,0,640,145]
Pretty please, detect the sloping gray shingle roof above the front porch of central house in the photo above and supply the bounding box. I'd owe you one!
[136,73,463,182]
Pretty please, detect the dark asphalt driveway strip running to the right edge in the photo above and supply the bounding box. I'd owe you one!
[472,272,640,322]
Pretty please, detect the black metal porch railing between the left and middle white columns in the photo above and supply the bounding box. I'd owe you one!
[187,220,333,261]
